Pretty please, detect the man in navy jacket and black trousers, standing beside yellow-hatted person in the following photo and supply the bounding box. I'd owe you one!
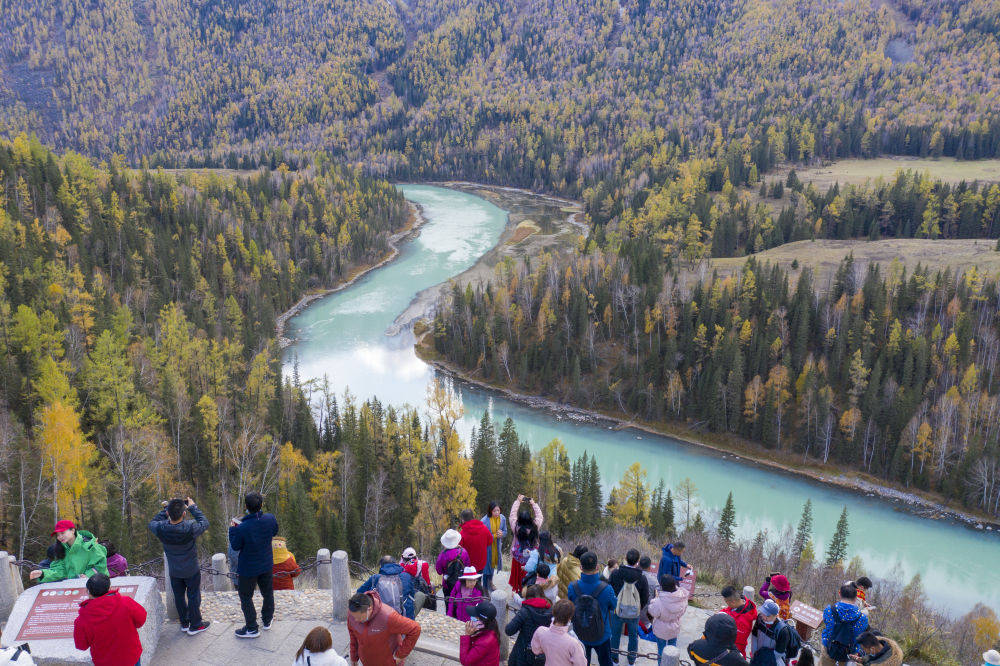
[229,492,278,638]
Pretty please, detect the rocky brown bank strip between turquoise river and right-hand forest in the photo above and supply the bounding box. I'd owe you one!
[415,348,1000,533]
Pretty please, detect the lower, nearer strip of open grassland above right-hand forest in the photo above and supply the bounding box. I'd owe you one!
[710,238,1000,287]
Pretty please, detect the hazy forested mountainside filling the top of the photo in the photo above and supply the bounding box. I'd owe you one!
[0,0,1000,195]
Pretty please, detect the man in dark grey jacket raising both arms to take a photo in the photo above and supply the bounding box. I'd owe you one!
[149,497,209,636]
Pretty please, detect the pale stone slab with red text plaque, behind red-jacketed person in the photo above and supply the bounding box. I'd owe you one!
[0,576,165,664]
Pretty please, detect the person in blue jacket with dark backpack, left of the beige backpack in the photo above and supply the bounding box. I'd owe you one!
[567,551,617,666]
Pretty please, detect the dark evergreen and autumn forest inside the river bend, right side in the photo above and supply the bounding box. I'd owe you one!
[433,250,1000,515]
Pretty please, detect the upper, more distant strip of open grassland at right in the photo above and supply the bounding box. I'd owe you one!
[767,157,1000,191]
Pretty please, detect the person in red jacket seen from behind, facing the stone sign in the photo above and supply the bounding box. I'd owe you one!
[73,573,146,666]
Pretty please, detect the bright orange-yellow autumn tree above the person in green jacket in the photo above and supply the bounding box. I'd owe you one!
[35,401,95,518]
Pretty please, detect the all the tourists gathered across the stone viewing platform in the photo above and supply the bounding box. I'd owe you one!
[30,493,988,666]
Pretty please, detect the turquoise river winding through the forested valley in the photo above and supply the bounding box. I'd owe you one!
[284,185,1000,615]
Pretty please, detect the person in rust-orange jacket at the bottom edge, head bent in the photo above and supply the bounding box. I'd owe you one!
[347,591,420,666]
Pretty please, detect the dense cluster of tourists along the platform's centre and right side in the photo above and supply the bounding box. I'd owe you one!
[348,496,916,666]
